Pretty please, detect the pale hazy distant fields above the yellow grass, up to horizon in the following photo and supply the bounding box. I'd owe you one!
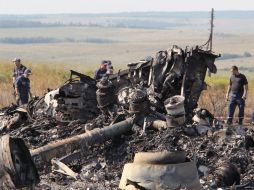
[0,11,254,71]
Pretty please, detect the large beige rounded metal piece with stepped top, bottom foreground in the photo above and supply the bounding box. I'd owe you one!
[119,152,201,190]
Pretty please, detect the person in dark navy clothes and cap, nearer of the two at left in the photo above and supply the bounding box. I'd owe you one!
[15,69,32,106]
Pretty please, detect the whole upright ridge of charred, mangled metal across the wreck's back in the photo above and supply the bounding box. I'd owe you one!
[24,45,219,123]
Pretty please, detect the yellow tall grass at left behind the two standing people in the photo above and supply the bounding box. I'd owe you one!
[0,60,92,107]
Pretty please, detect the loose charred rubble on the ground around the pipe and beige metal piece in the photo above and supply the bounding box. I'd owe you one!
[0,109,254,189]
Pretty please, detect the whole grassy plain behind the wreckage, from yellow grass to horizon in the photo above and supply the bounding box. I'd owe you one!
[0,12,254,120]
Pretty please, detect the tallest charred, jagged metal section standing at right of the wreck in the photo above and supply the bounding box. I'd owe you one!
[99,45,219,120]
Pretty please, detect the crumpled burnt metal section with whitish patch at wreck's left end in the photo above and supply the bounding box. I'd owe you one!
[28,70,99,123]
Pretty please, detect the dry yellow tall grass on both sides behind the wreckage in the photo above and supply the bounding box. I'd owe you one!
[0,60,254,121]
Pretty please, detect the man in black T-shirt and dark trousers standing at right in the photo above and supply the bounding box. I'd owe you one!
[226,66,248,125]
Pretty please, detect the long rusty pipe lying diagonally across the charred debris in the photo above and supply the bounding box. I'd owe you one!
[31,118,134,163]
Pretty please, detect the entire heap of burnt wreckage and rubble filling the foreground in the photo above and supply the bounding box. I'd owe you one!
[0,46,254,189]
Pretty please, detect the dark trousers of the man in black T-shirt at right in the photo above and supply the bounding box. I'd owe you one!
[227,94,245,124]
